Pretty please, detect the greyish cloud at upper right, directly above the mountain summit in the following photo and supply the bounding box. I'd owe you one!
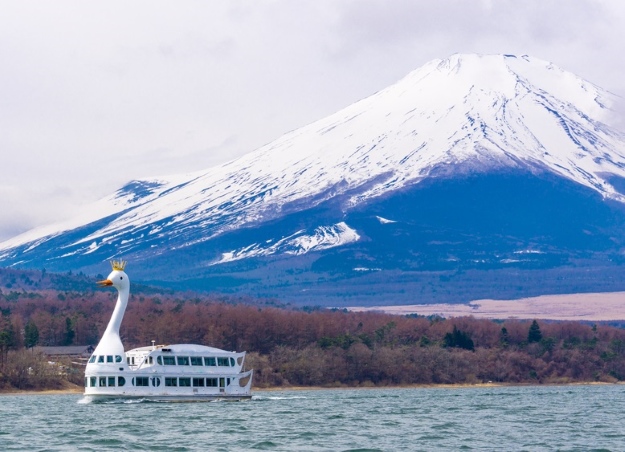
[326,0,625,94]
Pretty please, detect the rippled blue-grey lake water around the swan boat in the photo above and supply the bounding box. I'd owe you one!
[0,385,625,451]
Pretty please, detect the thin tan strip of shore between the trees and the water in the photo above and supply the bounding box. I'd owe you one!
[0,381,625,397]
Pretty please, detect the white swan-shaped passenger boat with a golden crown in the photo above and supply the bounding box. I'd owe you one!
[85,261,253,401]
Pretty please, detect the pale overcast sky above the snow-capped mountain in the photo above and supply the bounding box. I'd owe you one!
[0,0,625,241]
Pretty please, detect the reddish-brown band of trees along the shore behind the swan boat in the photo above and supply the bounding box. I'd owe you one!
[0,290,625,387]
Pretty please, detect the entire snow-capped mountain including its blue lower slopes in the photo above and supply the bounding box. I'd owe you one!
[0,55,625,306]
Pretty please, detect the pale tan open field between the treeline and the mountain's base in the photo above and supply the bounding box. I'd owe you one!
[347,292,625,322]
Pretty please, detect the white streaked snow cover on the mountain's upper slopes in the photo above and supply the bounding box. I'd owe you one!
[0,55,625,262]
